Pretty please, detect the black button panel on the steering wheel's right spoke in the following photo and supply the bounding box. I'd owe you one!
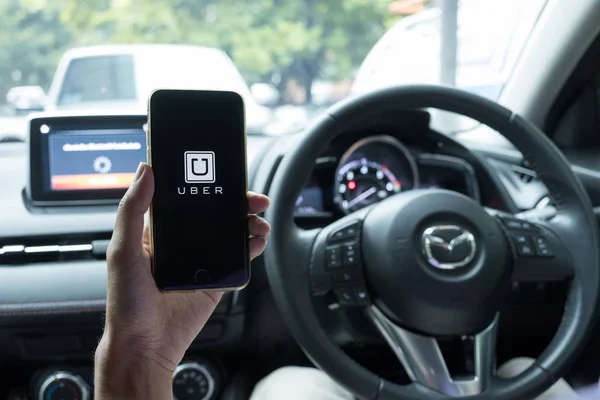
[488,213,575,282]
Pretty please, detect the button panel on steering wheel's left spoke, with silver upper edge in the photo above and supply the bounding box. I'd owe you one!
[310,210,371,309]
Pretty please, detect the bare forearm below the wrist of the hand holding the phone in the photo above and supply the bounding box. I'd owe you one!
[94,333,173,400]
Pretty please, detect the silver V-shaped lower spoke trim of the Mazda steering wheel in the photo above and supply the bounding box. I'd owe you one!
[367,306,498,397]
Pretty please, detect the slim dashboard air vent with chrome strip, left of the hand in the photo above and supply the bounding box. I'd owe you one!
[0,232,111,265]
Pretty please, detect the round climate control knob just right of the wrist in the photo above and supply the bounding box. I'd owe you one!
[173,362,215,400]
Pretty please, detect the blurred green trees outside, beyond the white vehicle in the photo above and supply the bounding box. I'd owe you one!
[0,0,399,101]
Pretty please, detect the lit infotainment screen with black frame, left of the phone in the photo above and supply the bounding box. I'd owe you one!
[29,116,146,205]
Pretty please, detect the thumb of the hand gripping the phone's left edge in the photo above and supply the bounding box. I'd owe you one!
[107,163,154,268]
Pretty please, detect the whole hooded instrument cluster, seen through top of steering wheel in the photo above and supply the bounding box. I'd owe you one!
[296,135,480,218]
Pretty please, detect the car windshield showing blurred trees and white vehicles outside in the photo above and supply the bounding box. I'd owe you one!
[0,0,546,142]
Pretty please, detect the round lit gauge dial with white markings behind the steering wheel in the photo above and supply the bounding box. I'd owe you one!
[337,158,402,216]
